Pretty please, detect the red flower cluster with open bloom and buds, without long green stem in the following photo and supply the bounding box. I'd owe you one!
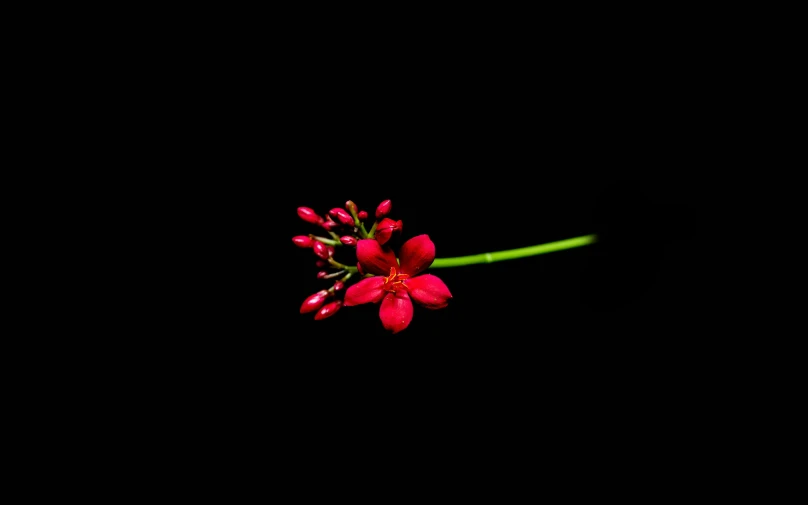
[292,200,452,333]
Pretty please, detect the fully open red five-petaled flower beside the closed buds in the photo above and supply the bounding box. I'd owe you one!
[345,235,452,333]
